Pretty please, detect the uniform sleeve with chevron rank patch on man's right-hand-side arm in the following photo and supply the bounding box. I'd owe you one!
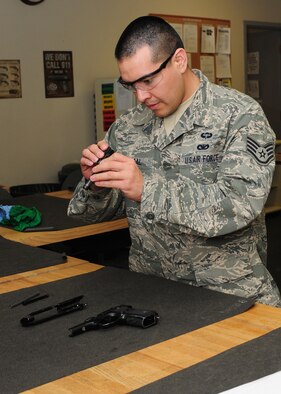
[141,104,275,238]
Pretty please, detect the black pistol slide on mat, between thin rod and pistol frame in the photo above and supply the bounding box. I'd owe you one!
[20,295,86,327]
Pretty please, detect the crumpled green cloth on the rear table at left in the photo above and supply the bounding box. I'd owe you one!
[2,205,42,231]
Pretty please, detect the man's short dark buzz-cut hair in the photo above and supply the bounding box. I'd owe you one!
[115,15,184,62]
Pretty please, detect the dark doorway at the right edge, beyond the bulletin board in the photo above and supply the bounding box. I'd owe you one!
[244,21,281,139]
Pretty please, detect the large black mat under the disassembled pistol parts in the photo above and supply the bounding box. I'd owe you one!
[0,268,252,393]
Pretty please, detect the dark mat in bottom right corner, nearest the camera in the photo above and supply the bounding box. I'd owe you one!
[134,328,281,394]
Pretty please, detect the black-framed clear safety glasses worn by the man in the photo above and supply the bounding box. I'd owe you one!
[118,50,176,92]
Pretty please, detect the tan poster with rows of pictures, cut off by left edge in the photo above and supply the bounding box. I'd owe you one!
[0,60,22,98]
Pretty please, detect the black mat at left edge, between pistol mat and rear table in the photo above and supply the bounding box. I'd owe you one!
[0,237,67,276]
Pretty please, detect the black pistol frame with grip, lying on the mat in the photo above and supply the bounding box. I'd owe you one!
[69,305,159,337]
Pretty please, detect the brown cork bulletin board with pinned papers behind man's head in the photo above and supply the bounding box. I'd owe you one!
[150,14,232,87]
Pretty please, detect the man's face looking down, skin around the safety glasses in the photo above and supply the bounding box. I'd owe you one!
[118,46,185,117]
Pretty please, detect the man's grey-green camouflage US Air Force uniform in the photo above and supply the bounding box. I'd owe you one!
[68,70,281,306]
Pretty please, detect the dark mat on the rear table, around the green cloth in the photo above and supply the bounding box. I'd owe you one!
[0,194,89,230]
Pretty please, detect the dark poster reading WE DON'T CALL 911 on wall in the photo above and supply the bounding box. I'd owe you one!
[43,51,74,98]
